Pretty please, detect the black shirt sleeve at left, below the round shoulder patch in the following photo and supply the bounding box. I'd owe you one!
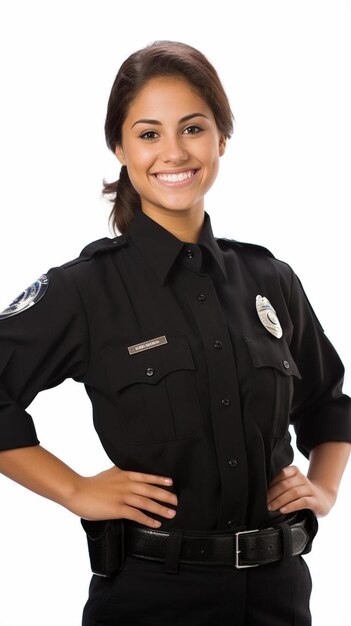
[0,268,89,450]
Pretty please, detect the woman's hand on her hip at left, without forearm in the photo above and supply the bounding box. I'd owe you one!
[65,466,178,528]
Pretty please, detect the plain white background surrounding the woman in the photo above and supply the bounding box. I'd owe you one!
[0,0,351,626]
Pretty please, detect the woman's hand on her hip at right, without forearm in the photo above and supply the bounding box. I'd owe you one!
[267,465,336,517]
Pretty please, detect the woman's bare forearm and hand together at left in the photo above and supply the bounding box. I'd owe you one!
[0,446,178,528]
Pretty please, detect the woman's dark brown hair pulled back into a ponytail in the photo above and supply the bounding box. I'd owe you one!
[102,41,234,233]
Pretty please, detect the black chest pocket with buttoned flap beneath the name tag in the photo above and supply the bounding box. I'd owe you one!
[107,335,201,444]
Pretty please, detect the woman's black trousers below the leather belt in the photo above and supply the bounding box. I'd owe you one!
[83,556,312,626]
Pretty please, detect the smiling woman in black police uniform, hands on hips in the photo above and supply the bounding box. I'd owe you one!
[0,42,351,626]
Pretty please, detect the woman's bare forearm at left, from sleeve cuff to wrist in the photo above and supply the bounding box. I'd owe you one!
[0,446,81,508]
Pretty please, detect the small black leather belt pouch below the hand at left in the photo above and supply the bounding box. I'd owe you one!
[81,519,125,576]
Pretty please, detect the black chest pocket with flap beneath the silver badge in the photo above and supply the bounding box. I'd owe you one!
[244,334,301,437]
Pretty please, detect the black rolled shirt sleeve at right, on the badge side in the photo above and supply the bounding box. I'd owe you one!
[290,274,351,458]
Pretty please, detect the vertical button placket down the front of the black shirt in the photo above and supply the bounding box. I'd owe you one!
[186,274,248,525]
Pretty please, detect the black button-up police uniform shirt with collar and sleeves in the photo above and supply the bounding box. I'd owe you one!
[0,210,351,529]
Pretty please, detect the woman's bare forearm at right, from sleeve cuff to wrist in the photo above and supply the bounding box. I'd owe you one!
[307,441,351,497]
